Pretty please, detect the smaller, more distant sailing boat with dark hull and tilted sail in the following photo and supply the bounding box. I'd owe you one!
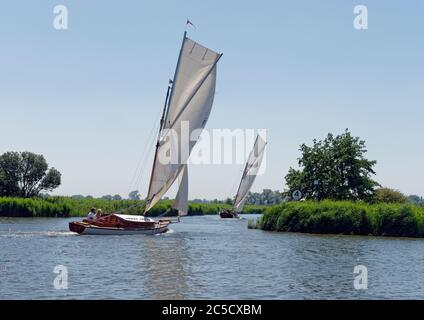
[219,135,266,218]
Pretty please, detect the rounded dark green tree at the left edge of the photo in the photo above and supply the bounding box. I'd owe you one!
[0,152,61,198]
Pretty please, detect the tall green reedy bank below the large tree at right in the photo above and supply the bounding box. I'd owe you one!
[250,201,424,237]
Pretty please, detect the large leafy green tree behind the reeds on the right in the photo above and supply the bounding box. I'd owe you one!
[285,129,379,200]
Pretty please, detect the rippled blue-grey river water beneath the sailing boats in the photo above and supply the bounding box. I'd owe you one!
[0,215,424,299]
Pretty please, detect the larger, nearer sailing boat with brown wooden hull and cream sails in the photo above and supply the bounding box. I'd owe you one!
[69,32,222,234]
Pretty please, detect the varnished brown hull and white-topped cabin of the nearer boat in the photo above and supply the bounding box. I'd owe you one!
[69,214,171,235]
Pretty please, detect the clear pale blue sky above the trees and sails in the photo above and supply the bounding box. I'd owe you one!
[0,0,424,199]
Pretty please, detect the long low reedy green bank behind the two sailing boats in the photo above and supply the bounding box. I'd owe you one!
[0,197,265,217]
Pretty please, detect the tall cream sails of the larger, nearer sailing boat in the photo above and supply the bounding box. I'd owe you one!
[145,33,222,214]
